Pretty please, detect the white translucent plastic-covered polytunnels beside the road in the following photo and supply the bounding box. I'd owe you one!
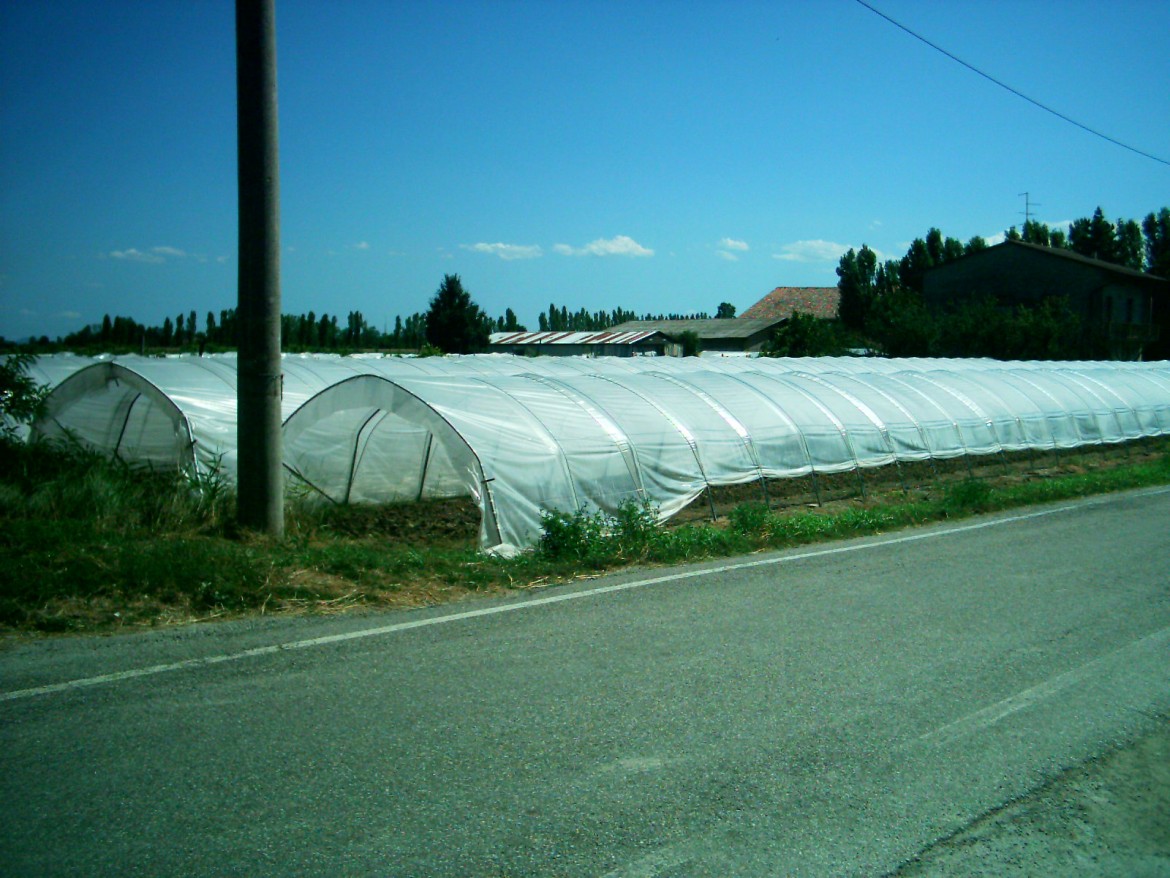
[25,355,1170,553]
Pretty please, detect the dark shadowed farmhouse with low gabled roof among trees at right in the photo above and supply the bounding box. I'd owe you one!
[923,241,1170,359]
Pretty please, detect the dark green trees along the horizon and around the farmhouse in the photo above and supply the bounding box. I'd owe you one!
[0,207,1170,359]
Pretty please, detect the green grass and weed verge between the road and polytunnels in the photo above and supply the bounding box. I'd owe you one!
[0,440,1170,635]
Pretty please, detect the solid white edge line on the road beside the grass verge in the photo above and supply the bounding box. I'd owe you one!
[0,488,1170,701]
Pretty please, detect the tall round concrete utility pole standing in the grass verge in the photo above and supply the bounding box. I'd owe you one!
[235,0,284,536]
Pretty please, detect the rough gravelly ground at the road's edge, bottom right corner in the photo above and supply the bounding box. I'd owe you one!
[894,720,1170,878]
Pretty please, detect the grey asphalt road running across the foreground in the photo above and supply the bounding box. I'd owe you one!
[0,491,1170,877]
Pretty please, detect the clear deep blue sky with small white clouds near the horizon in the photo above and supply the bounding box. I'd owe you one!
[0,0,1170,338]
